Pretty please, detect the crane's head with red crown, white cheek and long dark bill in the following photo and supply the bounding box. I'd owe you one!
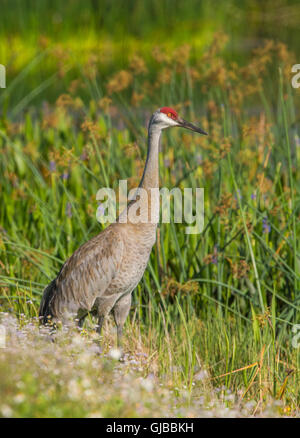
[150,106,207,135]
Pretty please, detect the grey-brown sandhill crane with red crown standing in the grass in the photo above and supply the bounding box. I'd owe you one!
[39,107,207,345]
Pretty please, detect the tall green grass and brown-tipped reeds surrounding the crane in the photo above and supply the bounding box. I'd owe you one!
[0,2,300,417]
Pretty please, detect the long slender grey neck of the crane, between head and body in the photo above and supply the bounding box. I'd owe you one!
[139,121,161,190]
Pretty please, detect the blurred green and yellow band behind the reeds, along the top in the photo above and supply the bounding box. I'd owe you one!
[0,0,300,109]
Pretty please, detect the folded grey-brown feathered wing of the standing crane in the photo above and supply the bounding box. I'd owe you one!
[40,226,124,320]
